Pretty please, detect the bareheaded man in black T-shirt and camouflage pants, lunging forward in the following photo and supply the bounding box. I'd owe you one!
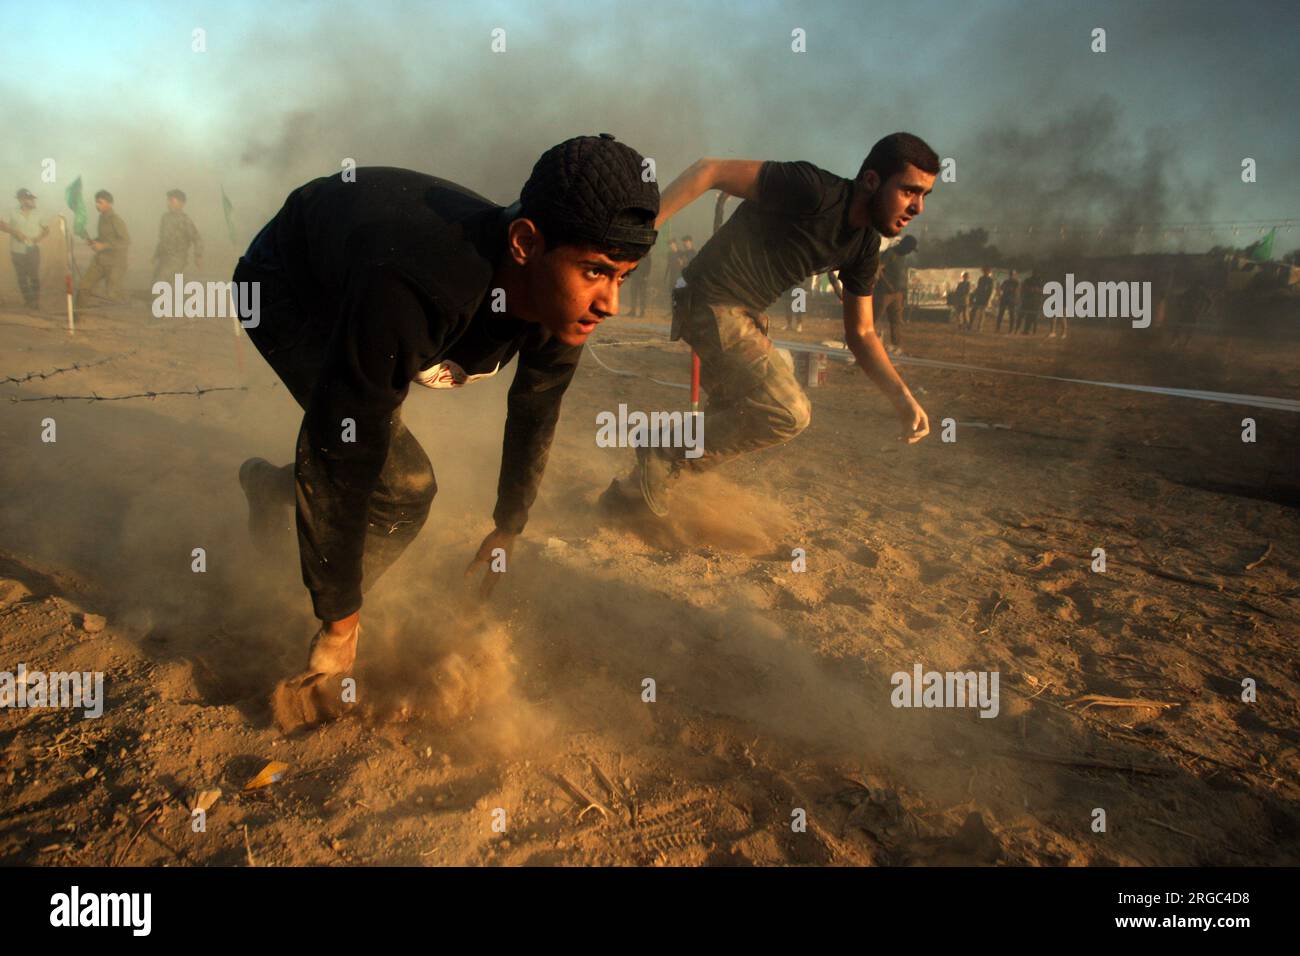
[602,133,939,516]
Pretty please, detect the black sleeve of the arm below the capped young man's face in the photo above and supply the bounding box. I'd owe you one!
[493,339,582,535]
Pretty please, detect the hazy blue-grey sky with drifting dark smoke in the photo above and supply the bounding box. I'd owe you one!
[0,0,1300,251]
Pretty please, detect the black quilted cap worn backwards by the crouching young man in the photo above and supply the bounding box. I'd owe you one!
[519,133,659,248]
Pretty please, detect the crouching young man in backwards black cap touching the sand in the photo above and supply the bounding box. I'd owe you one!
[234,134,659,685]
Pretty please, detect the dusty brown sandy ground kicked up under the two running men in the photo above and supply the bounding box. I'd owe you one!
[0,297,1300,865]
